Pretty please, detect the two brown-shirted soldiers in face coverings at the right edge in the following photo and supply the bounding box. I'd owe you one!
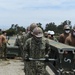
[59,25,75,47]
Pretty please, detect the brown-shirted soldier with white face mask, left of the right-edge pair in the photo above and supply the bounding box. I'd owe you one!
[59,25,70,43]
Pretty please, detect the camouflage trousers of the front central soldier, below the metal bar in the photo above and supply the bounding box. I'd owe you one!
[25,61,47,75]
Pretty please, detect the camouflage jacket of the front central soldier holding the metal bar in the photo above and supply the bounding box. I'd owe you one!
[24,37,50,58]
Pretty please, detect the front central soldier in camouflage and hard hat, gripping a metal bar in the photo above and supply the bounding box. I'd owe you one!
[24,27,50,75]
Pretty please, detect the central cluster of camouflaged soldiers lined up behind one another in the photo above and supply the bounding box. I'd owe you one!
[17,23,50,75]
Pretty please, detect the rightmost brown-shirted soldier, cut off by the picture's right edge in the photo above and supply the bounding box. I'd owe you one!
[65,26,75,47]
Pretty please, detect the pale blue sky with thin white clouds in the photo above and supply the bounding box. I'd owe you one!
[0,0,75,29]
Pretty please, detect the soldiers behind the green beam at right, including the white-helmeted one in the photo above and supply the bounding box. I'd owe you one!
[44,25,75,46]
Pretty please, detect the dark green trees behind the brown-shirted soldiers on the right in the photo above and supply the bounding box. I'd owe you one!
[45,20,72,35]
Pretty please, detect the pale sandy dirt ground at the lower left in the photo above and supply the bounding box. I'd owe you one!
[0,59,25,75]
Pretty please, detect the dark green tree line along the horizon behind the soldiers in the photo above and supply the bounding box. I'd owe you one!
[1,20,72,36]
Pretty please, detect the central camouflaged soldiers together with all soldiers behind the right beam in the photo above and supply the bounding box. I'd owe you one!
[17,23,75,75]
